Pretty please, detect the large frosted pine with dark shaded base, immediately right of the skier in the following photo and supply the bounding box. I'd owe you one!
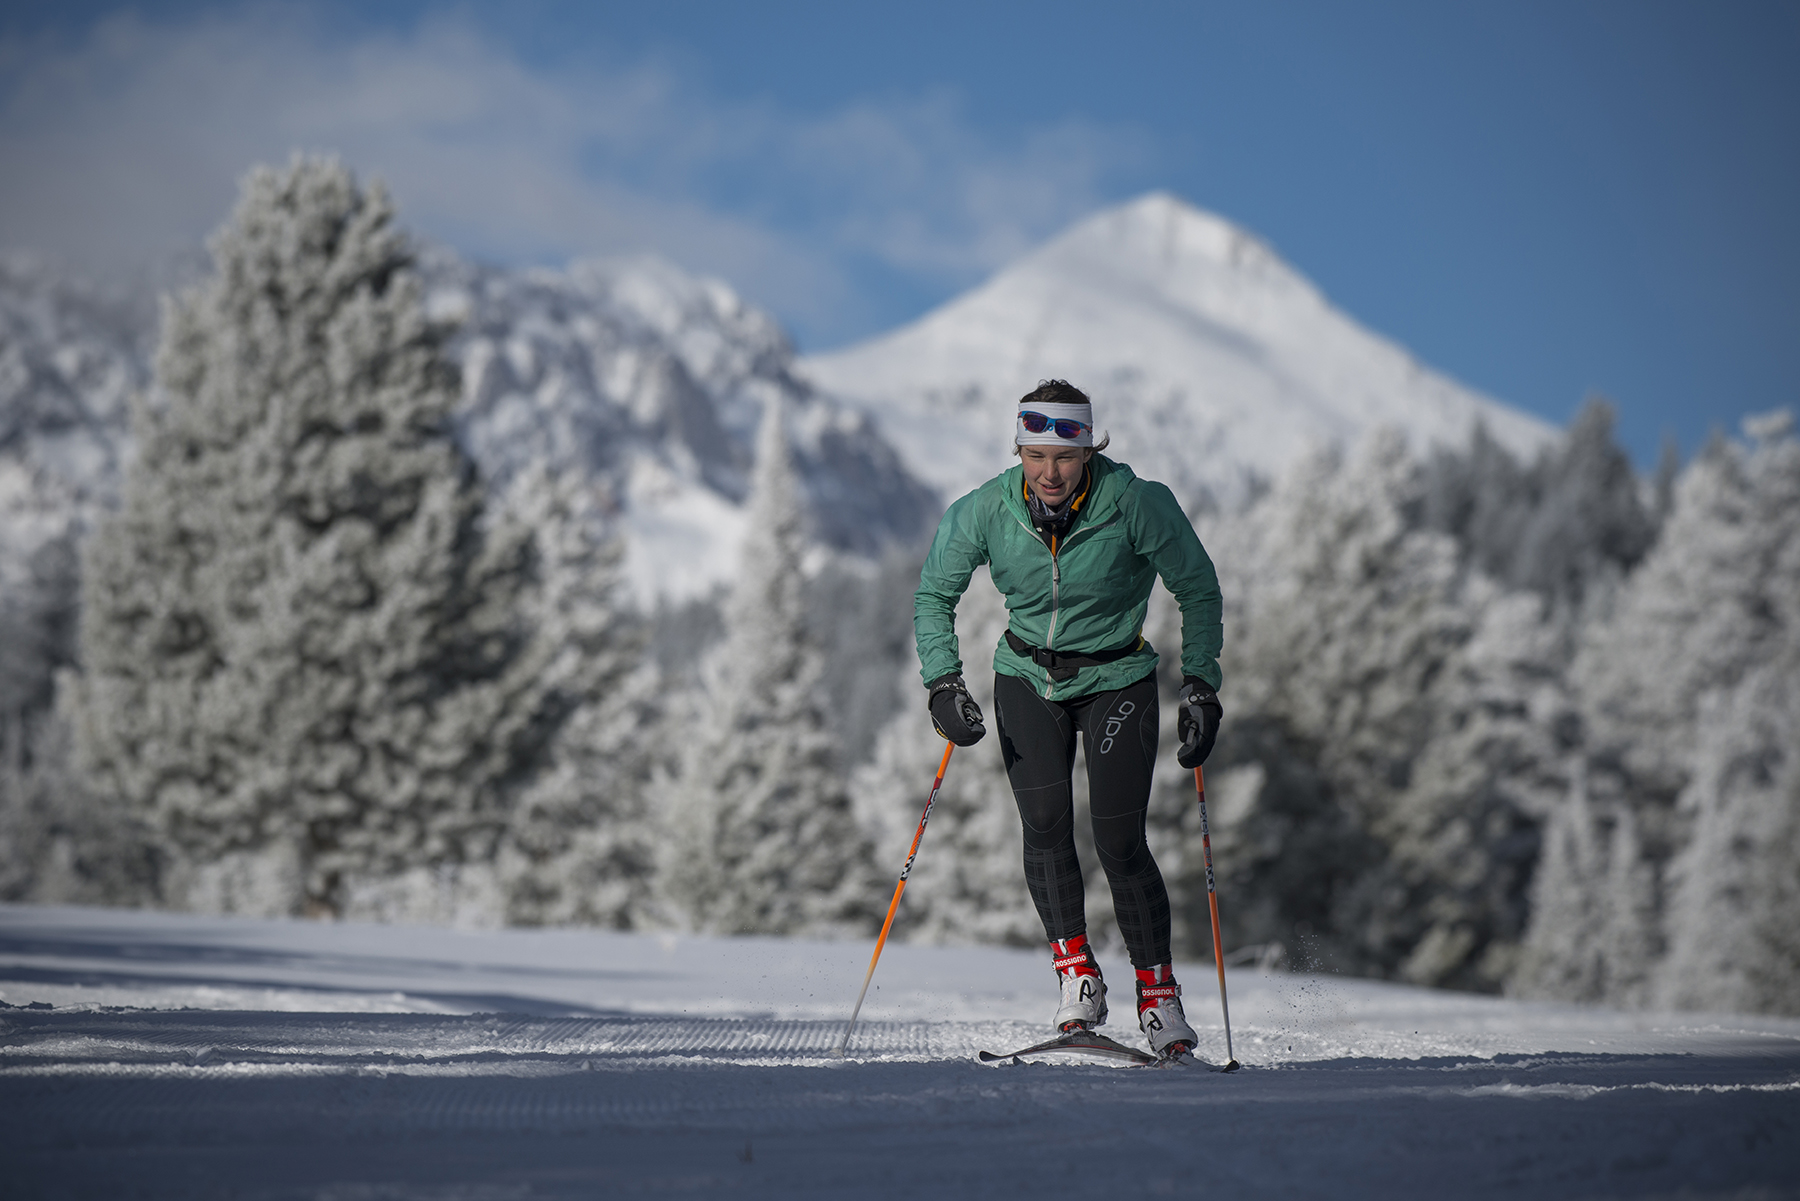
[1180,432,1469,972]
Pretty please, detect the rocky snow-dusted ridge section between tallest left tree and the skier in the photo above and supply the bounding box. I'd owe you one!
[425,254,936,607]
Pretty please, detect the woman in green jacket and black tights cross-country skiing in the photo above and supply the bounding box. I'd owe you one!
[913,380,1222,1055]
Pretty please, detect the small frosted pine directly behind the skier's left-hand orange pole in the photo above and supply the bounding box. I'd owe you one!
[851,571,1036,947]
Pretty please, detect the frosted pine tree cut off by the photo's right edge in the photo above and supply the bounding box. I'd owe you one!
[1648,414,1800,1014]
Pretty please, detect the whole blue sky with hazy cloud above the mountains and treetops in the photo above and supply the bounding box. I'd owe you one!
[0,0,1800,465]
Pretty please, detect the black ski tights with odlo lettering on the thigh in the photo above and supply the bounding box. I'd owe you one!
[994,675,1168,967]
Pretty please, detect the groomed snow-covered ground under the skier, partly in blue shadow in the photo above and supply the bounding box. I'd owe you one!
[0,906,1800,1199]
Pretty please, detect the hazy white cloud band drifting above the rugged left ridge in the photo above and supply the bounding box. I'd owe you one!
[0,7,1143,337]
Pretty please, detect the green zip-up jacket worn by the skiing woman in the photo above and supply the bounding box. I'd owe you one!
[913,454,1224,700]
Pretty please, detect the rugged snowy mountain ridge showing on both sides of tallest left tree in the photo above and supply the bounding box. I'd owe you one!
[0,252,938,607]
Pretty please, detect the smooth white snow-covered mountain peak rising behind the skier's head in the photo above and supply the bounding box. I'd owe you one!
[803,193,1553,504]
